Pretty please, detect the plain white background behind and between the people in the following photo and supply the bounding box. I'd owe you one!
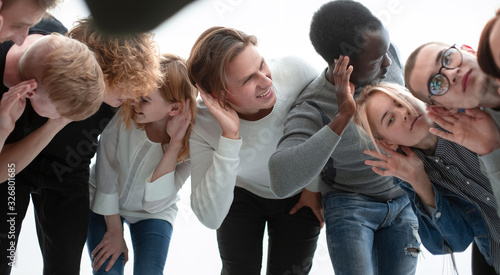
[12,0,500,275]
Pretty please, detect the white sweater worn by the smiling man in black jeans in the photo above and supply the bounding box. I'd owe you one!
[189,57,318,229]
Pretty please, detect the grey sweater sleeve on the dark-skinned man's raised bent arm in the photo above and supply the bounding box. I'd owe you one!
[269,102,340,198]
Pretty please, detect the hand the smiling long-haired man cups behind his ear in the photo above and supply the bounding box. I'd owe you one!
[196,84,240,139]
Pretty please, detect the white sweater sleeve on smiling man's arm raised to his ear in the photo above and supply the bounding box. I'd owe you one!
[189,128,242,229]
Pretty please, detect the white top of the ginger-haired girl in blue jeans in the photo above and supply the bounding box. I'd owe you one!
[89,116,190,226]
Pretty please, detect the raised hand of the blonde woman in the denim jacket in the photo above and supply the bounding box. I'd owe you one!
[364,144,435,207]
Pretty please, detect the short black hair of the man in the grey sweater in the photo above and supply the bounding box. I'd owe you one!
[309,0,383,64]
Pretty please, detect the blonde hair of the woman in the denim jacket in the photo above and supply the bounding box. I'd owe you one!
[353,82,423,153]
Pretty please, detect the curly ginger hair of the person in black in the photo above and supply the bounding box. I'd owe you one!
[68,18,162,101]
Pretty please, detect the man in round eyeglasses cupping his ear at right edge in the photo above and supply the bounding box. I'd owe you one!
[405,42,500,274]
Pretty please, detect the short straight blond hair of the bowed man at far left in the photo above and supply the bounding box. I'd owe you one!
[19,33,105,121]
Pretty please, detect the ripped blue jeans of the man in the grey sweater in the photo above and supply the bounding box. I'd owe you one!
[323,192,420,275]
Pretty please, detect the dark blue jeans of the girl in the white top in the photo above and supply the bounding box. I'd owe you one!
[87,211,173,275]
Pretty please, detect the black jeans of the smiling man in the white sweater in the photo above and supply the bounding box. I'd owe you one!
[217,187,321,275]
